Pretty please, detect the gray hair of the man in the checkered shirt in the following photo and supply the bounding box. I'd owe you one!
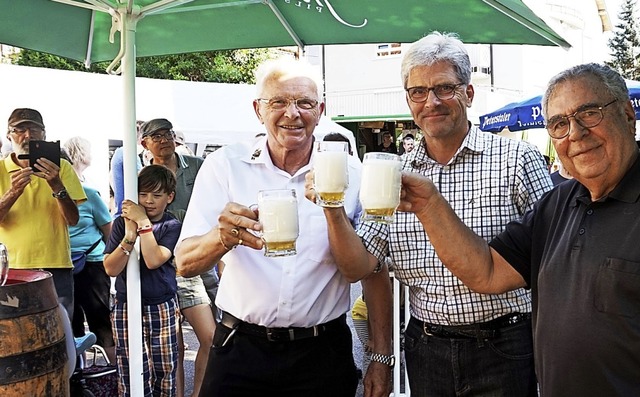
[400,32,471,88]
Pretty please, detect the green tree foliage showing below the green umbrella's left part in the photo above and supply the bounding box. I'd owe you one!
[11,49,275,84]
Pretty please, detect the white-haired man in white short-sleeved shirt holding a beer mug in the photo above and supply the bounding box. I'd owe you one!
[176,58,391,397]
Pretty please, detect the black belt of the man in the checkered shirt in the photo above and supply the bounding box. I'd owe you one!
[409,313,531,339]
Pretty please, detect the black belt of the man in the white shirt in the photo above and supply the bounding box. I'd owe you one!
[220,312,346,342]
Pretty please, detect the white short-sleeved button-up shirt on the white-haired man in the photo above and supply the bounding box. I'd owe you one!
[178,138,361,327]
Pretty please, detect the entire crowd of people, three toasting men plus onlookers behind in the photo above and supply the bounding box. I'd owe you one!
[0,32,640,397]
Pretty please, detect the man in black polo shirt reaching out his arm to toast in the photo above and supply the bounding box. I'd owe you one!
[400,64,640,396]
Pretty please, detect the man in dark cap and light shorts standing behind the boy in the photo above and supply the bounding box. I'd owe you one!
[140,119,215,395]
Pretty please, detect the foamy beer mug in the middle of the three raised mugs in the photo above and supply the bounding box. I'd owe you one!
[313,141,349,207]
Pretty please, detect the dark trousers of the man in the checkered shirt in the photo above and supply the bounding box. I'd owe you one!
[405,318,536,397]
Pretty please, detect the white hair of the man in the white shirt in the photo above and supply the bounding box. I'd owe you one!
[255,57,323,102]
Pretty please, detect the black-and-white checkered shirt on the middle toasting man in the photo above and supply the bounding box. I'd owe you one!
[358,127,553,325]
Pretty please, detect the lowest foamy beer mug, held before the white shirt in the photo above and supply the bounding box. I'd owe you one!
[258,189,299,257]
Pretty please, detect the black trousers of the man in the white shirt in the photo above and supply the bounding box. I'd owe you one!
[200,316,358,397]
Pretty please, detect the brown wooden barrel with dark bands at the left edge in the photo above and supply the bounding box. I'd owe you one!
[0,269,69,397]
